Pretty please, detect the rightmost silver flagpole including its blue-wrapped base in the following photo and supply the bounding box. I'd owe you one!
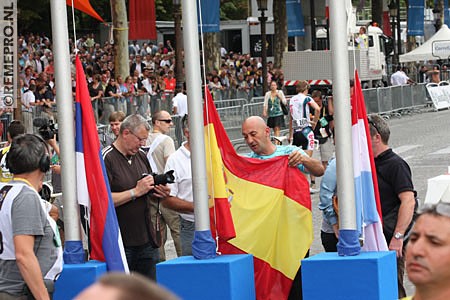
[330,0,360,255]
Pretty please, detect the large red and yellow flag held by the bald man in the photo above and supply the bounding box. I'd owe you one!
[204,87,313,300]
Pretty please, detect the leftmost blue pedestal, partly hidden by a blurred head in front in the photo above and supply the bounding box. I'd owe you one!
[53,260,106,300]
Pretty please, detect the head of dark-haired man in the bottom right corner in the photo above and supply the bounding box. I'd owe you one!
[404,202,450,300]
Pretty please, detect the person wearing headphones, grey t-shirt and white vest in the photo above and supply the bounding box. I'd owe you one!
[0,134,62,299]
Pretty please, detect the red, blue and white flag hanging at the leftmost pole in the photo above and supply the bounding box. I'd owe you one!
[75,55,128,272]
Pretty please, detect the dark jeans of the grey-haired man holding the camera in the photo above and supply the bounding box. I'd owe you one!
[125,242,159,280]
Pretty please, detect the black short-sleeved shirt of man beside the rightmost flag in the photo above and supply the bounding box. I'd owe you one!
[375,149,414,218]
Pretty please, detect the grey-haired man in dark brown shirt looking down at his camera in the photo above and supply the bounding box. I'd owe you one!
[102,115,169,279]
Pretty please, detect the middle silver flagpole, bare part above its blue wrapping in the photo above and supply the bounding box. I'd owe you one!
[182,0,210,231]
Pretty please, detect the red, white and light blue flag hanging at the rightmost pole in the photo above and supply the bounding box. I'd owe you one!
[351,70,388,251]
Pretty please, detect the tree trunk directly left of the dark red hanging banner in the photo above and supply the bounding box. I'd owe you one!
[111,0,130,79]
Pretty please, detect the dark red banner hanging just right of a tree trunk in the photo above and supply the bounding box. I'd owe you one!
[128,0,156,40]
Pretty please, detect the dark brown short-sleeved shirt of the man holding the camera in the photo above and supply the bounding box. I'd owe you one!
[102,145,156,247]
